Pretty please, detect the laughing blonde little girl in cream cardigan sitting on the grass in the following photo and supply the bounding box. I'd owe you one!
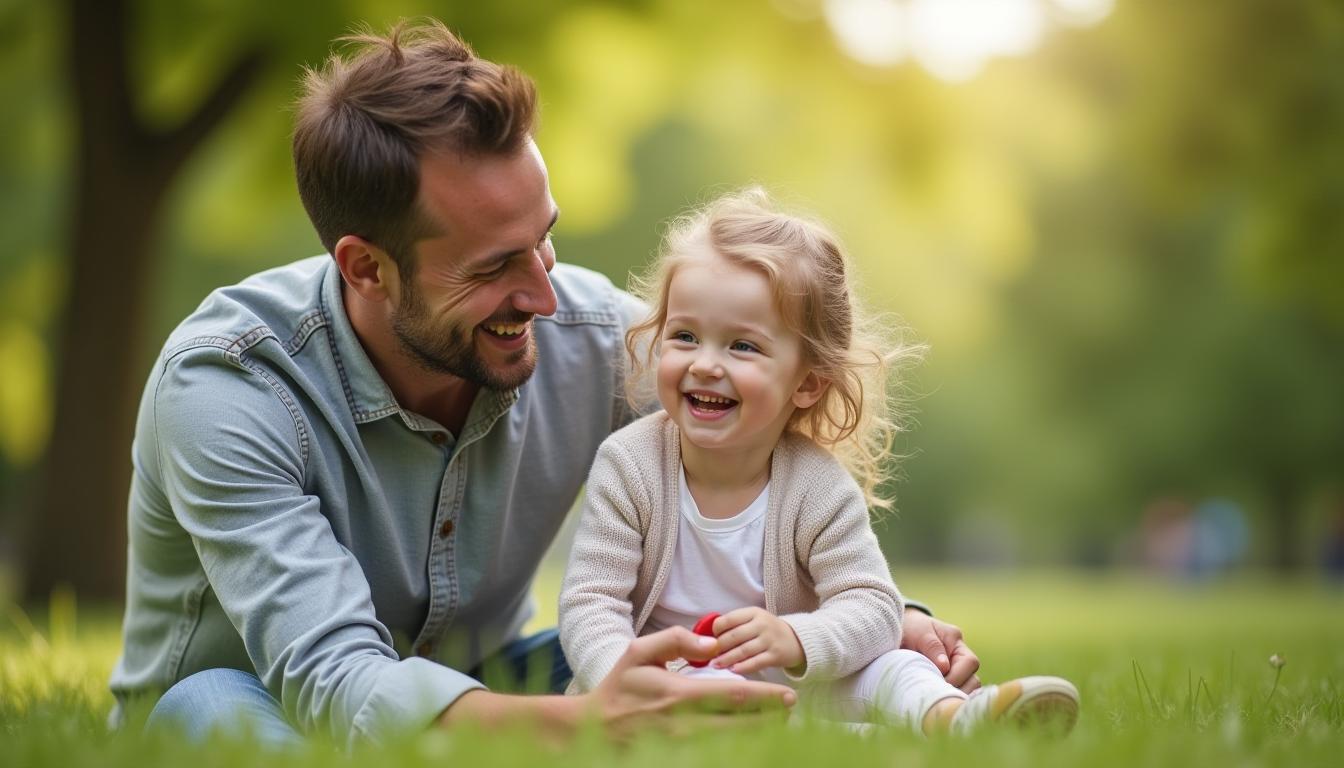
[560,191,1078,733]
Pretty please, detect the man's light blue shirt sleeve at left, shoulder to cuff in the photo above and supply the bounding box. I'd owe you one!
[153,350,482,744]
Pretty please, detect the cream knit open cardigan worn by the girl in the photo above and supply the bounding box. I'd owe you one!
[559,412,903,691]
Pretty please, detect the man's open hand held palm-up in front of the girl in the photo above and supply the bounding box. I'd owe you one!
[586,627,797,736]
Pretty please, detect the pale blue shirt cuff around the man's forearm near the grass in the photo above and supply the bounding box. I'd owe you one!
[349,656,485,746]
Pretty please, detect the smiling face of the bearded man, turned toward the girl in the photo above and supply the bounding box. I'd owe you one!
[391,141,559,390]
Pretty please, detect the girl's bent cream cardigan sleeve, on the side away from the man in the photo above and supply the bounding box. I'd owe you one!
[781,469,902,682]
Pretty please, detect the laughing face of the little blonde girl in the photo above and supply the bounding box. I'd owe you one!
[657,256,820,462]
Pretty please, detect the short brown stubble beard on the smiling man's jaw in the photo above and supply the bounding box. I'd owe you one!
[392,280,538,391]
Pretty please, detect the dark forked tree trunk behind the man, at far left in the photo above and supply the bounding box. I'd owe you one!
[24,0,262,601]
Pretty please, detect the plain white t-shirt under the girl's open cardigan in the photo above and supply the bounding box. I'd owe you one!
[644,467,770,633]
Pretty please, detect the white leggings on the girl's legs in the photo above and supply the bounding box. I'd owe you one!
[681,650,966,732]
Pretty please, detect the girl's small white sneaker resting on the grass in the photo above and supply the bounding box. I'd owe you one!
[952,675,1078,734]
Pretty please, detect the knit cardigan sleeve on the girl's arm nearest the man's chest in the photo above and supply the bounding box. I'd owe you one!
[559,440,644,693]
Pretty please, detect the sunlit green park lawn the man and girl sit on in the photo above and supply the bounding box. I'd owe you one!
[0,570,1344,768]
